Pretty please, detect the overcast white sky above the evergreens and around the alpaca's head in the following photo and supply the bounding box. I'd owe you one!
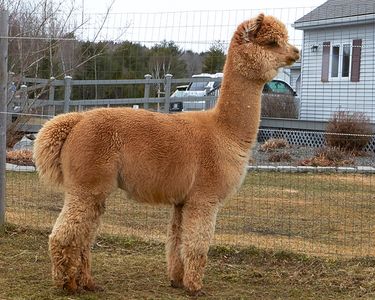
[75,0,325,52]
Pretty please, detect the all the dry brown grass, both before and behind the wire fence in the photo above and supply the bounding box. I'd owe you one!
[0,172,375,300]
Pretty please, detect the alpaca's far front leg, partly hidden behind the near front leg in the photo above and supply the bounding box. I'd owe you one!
[166,205,184,287]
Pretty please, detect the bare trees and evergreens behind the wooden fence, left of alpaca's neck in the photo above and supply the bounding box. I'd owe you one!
[4,0,225,99]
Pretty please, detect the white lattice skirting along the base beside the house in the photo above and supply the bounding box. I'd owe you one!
[258,128,375,152]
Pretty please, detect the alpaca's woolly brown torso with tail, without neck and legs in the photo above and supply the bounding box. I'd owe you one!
[35,109,229,203]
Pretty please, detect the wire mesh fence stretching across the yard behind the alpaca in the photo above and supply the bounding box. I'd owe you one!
[2,1,375,257]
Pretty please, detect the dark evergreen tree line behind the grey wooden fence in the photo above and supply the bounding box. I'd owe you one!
[16,39,225,99]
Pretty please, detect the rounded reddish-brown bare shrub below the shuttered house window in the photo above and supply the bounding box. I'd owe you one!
[326,111,372,151]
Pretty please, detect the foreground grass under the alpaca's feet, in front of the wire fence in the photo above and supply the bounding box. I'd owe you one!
[0,225,375,300]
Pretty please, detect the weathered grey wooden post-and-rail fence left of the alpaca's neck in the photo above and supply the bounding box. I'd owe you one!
[8,74,221,118]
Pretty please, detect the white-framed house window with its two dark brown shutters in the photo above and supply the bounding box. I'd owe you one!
[321,39,362,82]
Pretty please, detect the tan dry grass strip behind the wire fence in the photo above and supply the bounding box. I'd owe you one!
[6,172,375,258]
